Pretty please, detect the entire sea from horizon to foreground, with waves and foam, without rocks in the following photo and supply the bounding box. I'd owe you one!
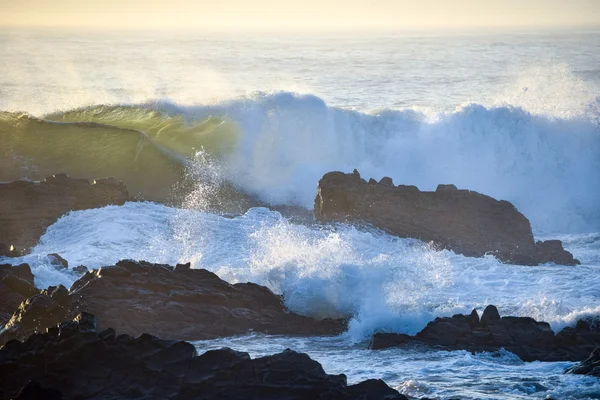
[0,32,600,399]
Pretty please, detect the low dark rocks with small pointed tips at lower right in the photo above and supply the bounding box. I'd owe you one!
[369,306,600,361]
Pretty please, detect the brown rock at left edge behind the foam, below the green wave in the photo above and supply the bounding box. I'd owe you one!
[0,174,129,252]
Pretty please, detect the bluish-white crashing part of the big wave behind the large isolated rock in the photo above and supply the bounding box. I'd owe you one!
[160,84,600,233]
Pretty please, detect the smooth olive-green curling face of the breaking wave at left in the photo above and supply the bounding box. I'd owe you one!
[0,106,235,201]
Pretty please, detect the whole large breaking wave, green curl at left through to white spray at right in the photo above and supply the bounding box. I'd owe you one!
[0,92,600,233]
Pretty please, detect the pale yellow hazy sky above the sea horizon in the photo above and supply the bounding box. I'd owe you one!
[0,0,600,31]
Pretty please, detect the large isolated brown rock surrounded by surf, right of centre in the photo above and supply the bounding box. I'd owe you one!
[314,170,579,265]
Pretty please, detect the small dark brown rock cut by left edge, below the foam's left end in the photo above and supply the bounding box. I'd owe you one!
[0,264,39,327]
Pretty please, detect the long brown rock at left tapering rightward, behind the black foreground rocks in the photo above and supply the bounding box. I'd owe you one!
[0,261,346,344]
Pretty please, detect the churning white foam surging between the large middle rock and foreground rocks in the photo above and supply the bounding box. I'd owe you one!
[5,203,600,341]
